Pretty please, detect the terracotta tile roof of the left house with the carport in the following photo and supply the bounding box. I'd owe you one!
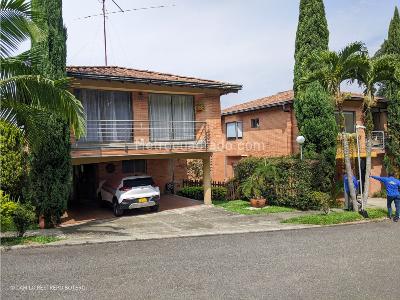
[67,66,242,91]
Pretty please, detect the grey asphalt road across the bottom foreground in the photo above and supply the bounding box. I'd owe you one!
[1,221,400,299]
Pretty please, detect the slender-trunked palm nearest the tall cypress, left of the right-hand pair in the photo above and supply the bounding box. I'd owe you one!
[301,42,367,210]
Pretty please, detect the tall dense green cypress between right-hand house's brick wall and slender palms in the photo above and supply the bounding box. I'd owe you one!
[293,0,337,192]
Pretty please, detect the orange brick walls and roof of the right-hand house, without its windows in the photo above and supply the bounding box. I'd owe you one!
[212,92,387,194]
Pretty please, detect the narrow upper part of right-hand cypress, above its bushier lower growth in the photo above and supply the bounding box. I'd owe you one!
[293,0,329,95]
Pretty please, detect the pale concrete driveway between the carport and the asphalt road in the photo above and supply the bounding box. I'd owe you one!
[0,205,318,248]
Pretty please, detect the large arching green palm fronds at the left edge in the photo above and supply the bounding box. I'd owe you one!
[0,0,85,137]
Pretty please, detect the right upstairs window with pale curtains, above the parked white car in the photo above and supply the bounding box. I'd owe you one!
[149,94,195,142]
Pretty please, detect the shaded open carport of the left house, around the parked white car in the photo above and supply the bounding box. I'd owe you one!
[62,150,211,224]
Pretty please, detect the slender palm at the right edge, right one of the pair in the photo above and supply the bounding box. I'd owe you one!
[357,55,400,207]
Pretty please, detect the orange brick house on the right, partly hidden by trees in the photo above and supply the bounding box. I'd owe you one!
[217,91,387,193]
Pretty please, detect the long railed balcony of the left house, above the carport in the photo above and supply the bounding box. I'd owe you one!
[72,120,209,150]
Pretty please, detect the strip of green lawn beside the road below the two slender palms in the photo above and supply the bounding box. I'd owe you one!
[282,208,387,225]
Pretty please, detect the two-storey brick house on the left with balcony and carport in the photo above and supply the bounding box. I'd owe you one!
[67,66,242,203]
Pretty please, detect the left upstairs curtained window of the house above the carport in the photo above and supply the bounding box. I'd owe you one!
[75,89,132,142]
